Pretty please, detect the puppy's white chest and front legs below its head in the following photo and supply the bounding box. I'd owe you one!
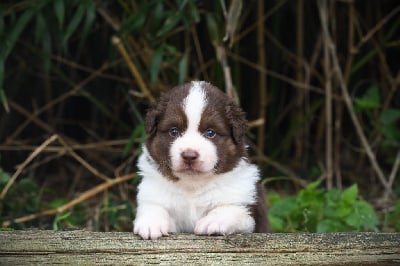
[134,148,259,239]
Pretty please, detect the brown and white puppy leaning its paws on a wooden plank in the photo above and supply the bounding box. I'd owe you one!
[134,81,267,239]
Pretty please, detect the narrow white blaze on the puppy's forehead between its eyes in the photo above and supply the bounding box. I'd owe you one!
[183,81,207,131]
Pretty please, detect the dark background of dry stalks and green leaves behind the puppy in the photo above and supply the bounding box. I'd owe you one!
[0,0,400,232]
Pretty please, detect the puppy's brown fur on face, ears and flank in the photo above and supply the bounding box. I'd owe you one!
[145,83,268,232]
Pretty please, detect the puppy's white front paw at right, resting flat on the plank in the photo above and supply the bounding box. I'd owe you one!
[194,206,255,235]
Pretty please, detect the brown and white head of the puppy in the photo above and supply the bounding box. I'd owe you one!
[145,81,246,180]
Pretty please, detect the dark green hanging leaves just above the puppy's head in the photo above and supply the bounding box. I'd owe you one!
[119,0,200,87]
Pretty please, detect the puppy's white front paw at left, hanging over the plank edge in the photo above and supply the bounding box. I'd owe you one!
[133,213,171,240]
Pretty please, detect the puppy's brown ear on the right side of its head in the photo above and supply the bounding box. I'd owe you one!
[226,101,247,145]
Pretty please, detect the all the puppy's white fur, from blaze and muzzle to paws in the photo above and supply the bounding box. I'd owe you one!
[134,82,259,239]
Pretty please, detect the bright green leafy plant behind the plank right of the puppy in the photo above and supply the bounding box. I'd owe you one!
[268,181,378,232]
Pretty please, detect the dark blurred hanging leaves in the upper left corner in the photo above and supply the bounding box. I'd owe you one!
[0,0,96,103]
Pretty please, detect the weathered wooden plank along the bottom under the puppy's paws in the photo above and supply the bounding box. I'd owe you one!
[0,230,400,265]
